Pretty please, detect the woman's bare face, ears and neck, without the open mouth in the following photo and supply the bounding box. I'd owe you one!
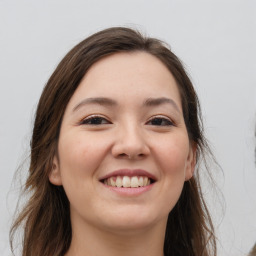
[49,52,196,256]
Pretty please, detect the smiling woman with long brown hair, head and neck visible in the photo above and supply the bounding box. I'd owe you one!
[11,27,216,256]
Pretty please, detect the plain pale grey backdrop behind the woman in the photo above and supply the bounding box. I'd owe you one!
[0,0,256,256]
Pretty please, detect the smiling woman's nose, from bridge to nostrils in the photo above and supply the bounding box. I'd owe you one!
[112,125,150,160]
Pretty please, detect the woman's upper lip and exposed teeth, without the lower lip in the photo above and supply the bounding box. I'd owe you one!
[100,169,156,188]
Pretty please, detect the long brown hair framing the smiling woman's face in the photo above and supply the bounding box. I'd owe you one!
[10,27,216,256]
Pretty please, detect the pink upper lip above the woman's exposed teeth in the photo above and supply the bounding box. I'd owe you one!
[99,169,156,181]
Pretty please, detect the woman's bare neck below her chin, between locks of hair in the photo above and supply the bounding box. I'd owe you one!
[65,214,166,256]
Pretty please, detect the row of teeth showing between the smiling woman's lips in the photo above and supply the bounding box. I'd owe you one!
[101,176,155,188]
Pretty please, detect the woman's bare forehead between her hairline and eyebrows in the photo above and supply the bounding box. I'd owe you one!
[66,52,181,108]
